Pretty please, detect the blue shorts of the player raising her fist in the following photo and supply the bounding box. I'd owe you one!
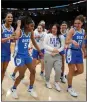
[14,55,32,66]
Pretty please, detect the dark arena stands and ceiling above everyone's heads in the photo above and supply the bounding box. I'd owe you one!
[1,0,87,29]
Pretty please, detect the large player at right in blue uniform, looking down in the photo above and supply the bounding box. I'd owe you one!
[66,15,86,97]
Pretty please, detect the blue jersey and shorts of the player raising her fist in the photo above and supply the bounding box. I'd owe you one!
[14,30,32,66]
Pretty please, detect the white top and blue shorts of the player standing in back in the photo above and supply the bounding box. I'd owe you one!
[32,31,46,59]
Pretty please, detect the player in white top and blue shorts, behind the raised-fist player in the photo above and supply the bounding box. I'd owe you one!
[32,24,45,76]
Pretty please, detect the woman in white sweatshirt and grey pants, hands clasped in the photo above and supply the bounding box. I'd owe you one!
[44,24,65,92]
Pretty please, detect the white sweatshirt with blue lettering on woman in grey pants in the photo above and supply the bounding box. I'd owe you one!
[44,33,65,54]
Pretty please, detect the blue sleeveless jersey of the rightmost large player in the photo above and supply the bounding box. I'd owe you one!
[70,28,85,49]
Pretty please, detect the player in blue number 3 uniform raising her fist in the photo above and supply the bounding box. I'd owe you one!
[11,16,42,98]
